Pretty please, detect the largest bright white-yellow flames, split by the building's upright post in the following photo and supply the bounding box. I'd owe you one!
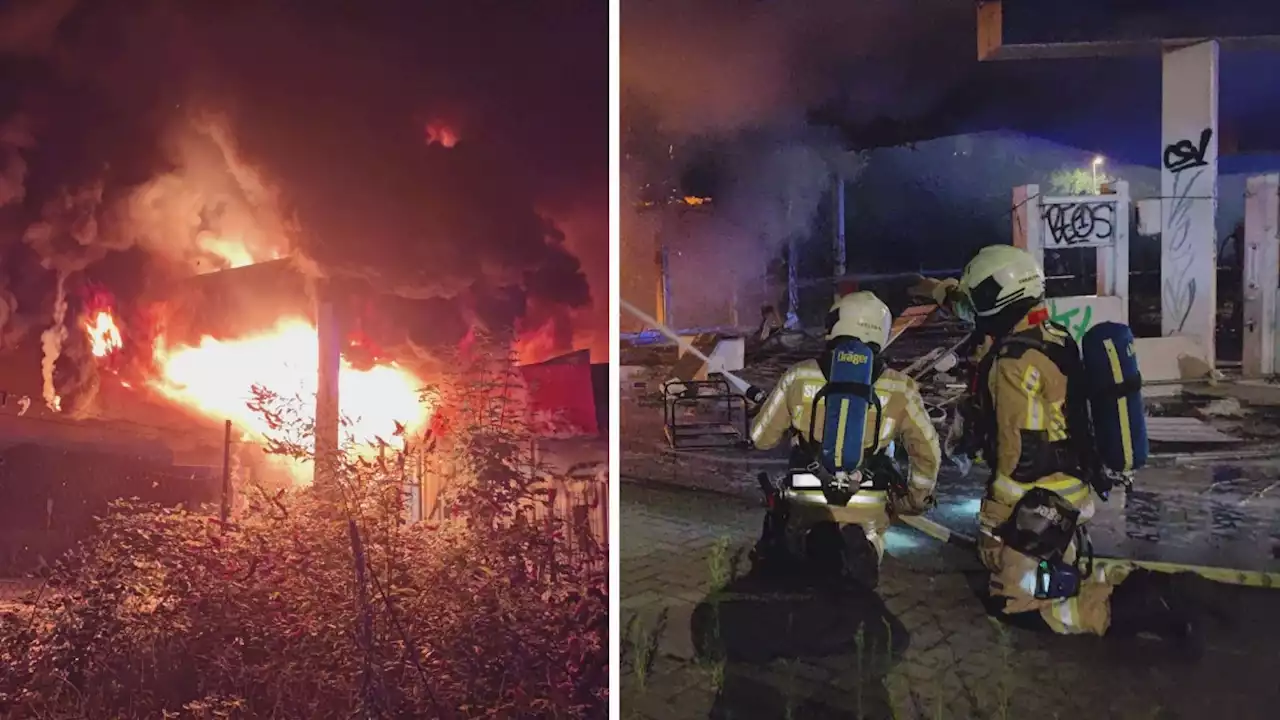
[148,312,430,471]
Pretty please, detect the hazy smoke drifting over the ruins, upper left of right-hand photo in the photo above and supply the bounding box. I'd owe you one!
[622,0,973,327]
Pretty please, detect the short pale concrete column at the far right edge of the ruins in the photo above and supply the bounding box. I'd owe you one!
[1240,174,1280,378]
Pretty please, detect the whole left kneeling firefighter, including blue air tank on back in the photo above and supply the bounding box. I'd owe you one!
[751,292,941,588]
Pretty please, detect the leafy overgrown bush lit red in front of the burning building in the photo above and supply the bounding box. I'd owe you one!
[0,345,608,717]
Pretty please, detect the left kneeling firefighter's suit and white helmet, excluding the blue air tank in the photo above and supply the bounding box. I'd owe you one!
[750,292,941,588]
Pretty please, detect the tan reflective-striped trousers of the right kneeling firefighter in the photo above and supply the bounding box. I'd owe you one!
[978,500,1123,635]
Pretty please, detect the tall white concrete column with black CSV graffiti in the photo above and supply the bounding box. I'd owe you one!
[1160,40,1219,366]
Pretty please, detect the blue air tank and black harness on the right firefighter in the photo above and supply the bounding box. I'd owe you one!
[974,322,1148,500]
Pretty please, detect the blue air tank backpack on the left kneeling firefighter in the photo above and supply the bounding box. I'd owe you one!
[801,338,883,506]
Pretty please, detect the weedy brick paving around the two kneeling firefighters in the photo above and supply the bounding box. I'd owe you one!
[621,366,1280,720]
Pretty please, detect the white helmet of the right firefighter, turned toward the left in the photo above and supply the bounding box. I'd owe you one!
[955,245,1044,320]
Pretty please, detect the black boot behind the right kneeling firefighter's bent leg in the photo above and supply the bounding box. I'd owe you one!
[1107,569,1203,660]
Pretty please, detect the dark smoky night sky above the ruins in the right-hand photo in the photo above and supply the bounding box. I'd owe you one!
[622,0,1280,173]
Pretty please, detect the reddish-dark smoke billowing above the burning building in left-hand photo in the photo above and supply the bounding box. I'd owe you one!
[0,0,608,407]
